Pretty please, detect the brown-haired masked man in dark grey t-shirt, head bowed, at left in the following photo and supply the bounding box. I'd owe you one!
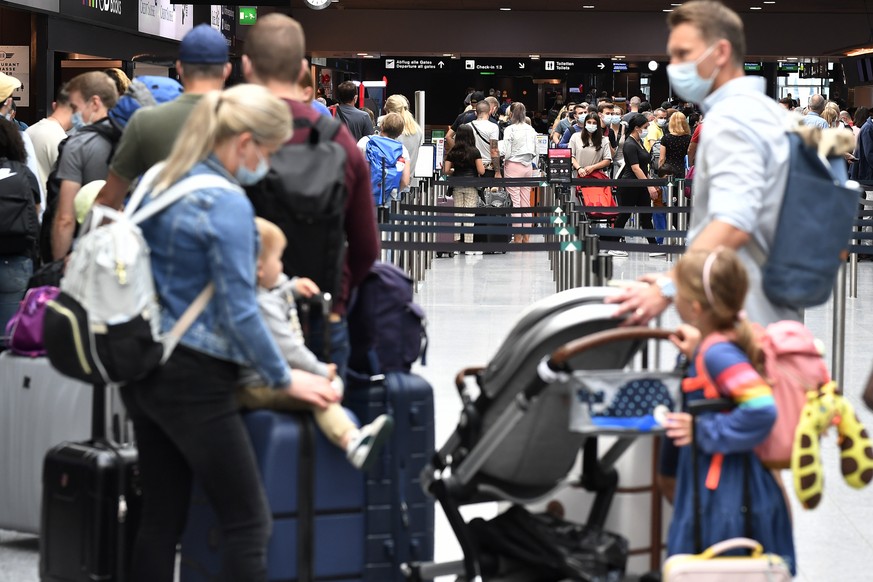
[52,71,118,260]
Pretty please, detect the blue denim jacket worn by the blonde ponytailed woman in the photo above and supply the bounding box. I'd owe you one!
[140,157,291,387]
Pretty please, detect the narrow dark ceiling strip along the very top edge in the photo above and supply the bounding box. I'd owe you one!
[292,0,867,13]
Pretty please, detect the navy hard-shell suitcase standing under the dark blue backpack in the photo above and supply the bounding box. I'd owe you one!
[344,372,434,582]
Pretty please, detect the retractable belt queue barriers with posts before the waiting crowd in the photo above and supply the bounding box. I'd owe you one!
[378,176,688,290]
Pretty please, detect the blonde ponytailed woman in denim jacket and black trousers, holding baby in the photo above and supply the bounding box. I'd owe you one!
[121,85,337,582]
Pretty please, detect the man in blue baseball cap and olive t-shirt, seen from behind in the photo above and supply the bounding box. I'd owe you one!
[96,24,231,208]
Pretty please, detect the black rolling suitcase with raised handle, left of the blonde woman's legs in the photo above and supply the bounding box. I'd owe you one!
[39,386,142,582]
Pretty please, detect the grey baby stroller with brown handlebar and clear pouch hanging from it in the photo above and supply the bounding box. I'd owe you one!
[404,287,680,582]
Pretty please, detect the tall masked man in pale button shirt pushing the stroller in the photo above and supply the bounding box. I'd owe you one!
[610,0,801,325]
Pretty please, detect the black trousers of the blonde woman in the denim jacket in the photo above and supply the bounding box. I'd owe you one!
[121,346,271,582]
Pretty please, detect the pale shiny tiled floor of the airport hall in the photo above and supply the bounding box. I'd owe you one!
[0,253,873,582]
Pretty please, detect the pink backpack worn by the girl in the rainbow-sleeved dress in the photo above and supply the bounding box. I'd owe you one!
[697,320,831,469]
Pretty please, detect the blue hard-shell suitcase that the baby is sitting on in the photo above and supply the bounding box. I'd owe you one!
[181,410,364,582]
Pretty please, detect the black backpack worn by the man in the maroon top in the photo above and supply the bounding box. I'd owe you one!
[246,116,348,297]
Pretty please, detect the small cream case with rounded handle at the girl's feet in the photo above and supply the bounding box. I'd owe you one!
[664,538,791,582]
